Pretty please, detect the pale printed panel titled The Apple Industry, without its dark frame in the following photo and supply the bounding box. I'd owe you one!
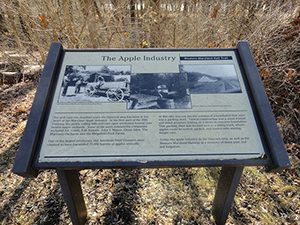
[37,50,265,163]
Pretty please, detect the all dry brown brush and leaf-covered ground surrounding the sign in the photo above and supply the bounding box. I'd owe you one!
[0,0,300,224]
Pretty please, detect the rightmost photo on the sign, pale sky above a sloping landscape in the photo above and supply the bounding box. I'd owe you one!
[179,64,242,94]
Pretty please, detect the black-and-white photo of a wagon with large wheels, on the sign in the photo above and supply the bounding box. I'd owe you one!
[58,65,130,103]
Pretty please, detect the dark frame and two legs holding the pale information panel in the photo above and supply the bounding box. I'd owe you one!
[13,41,291,224]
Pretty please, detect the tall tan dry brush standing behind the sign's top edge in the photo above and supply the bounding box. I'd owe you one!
[1,0,299,54]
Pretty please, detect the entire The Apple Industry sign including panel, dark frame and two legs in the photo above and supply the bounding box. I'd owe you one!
[13,42,291,224]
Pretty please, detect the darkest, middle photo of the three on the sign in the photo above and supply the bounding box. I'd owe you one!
[127,73,191,109]
